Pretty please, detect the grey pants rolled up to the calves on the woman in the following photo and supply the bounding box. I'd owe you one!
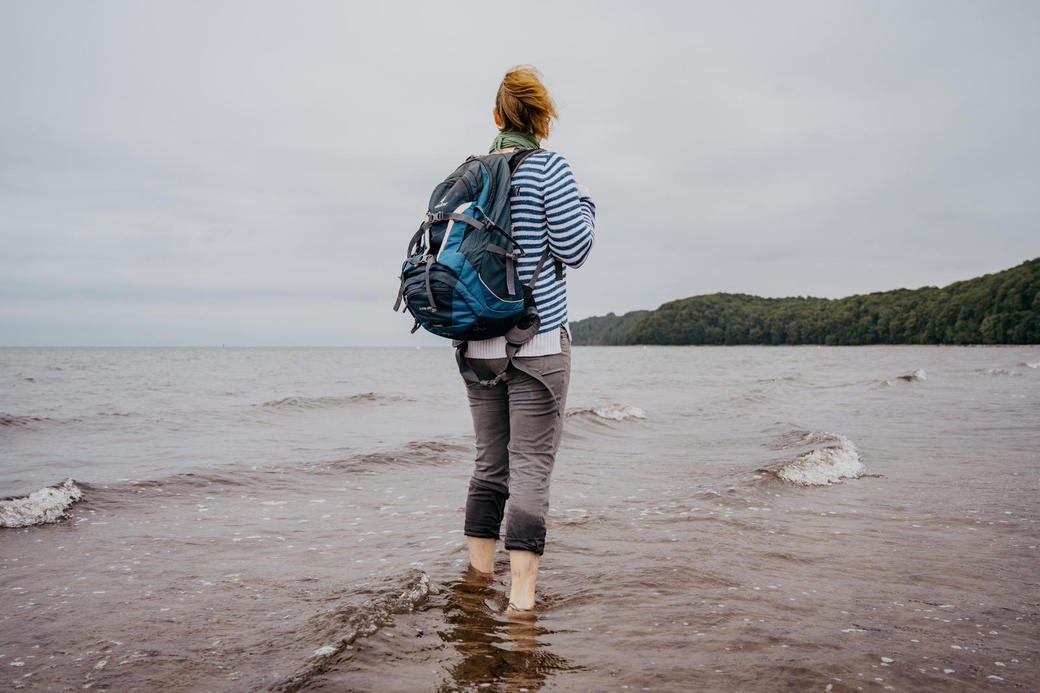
[465,330,571,555]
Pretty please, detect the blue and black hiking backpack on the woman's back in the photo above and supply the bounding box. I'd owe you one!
[394,149,562,349]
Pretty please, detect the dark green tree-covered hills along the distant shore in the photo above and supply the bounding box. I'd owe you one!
[570,258,1040,345]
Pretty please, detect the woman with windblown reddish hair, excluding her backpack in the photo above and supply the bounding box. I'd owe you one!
[465,66,596,612]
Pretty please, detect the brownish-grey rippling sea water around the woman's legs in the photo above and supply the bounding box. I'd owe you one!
[0,347,1040,691]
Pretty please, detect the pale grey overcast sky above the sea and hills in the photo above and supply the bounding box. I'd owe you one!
[0,0,1040,345]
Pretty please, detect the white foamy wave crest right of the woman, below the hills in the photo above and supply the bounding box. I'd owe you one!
[759,431,866,486]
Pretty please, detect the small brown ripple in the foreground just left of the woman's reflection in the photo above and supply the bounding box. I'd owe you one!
[272,570,430,693]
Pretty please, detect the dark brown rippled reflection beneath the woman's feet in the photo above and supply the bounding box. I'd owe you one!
[438,568,573,691]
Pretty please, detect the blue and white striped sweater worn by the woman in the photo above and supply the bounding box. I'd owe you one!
[466,152,596,359]
